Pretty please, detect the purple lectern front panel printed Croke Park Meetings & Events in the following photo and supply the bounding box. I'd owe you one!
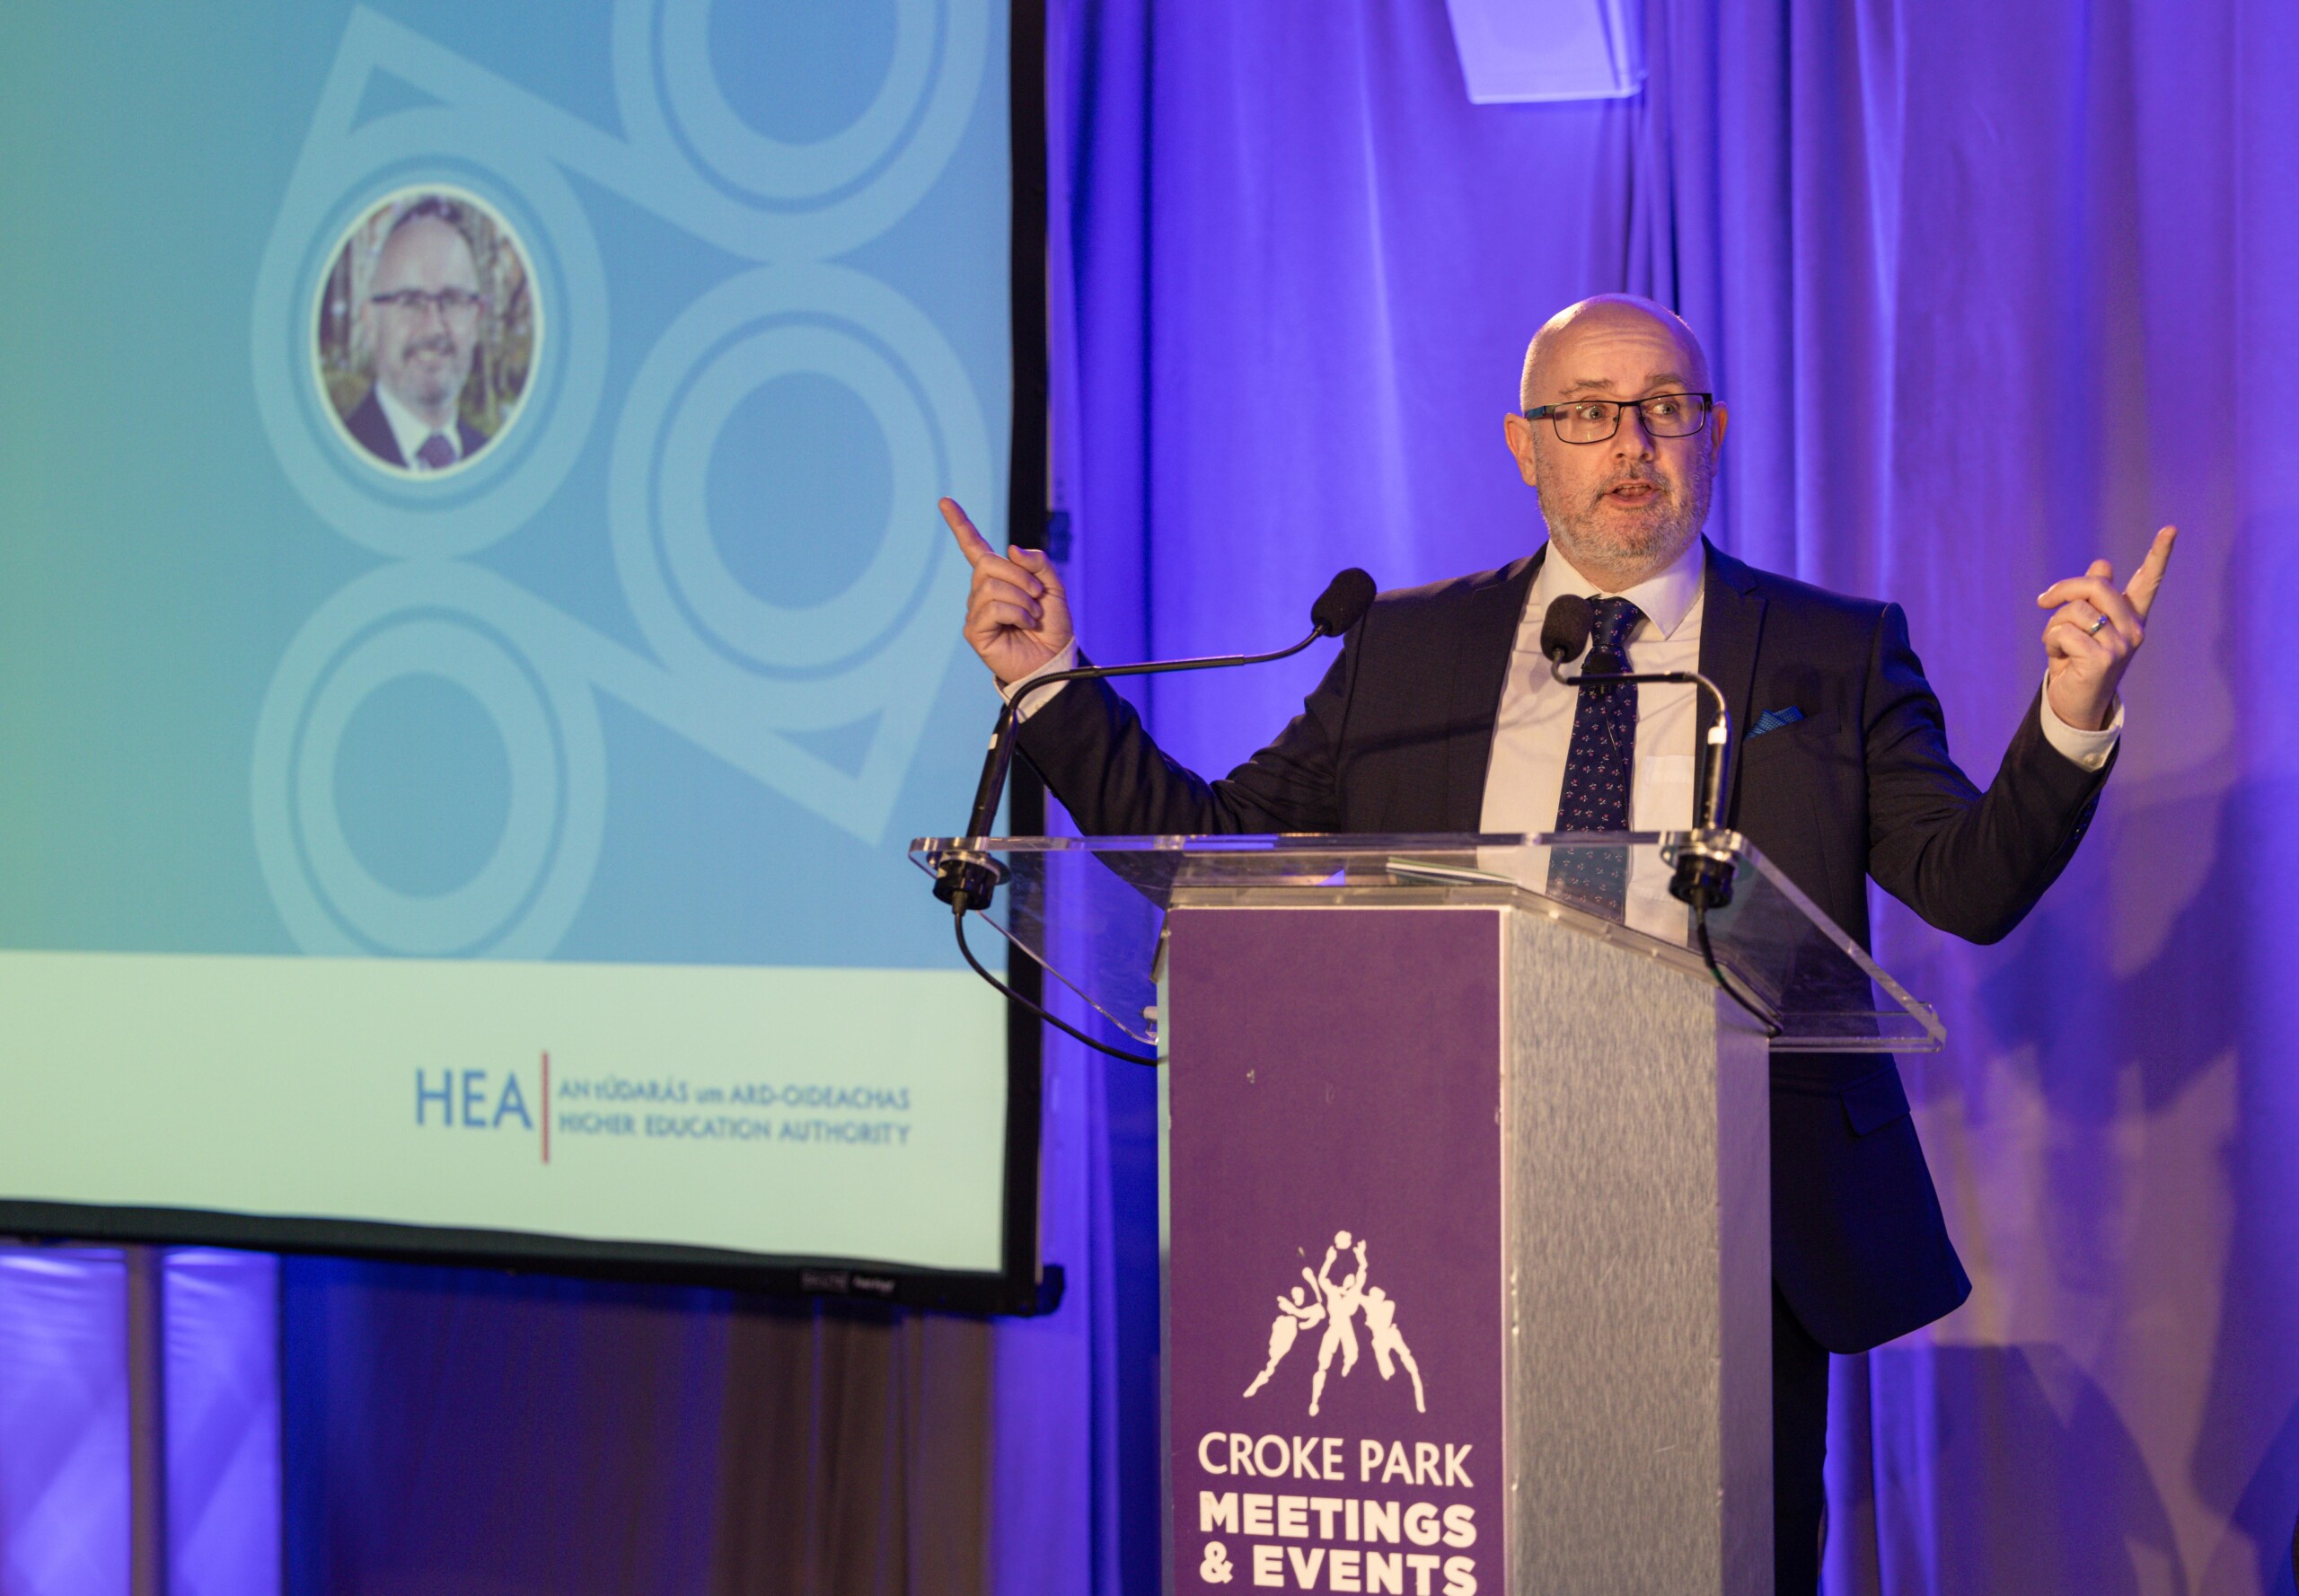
[1166,908,1508,1596]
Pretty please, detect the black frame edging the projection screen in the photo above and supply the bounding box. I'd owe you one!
[0,0,1062,1316]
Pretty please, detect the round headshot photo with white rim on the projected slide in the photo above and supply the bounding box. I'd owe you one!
[313,184,542,479]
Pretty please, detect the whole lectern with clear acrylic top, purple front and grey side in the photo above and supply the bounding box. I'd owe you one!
[912,834,1942,1596]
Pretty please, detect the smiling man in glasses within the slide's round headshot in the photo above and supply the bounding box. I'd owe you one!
[345,196,488,473]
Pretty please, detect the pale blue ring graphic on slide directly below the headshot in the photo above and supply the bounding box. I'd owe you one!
[253,563,607,959]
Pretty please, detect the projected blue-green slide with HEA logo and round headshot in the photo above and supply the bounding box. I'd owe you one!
[0,0,1035,1274]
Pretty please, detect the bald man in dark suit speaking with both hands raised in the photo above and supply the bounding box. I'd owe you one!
[943,296,2175,1596]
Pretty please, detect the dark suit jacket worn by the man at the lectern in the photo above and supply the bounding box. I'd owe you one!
[1021,547,2113,1353]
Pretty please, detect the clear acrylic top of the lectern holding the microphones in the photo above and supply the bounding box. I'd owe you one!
[911,833,1947,1054]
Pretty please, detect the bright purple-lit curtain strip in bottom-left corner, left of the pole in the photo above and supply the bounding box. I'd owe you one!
[0,1247,128,1596]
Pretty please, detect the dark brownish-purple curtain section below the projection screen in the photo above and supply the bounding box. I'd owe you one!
[280,1258,988,1596]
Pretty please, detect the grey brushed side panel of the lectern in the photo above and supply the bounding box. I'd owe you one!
[1502,911,1773,1596]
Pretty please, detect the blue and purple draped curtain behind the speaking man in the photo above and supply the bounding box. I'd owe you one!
[1025,0,2299,1593]
